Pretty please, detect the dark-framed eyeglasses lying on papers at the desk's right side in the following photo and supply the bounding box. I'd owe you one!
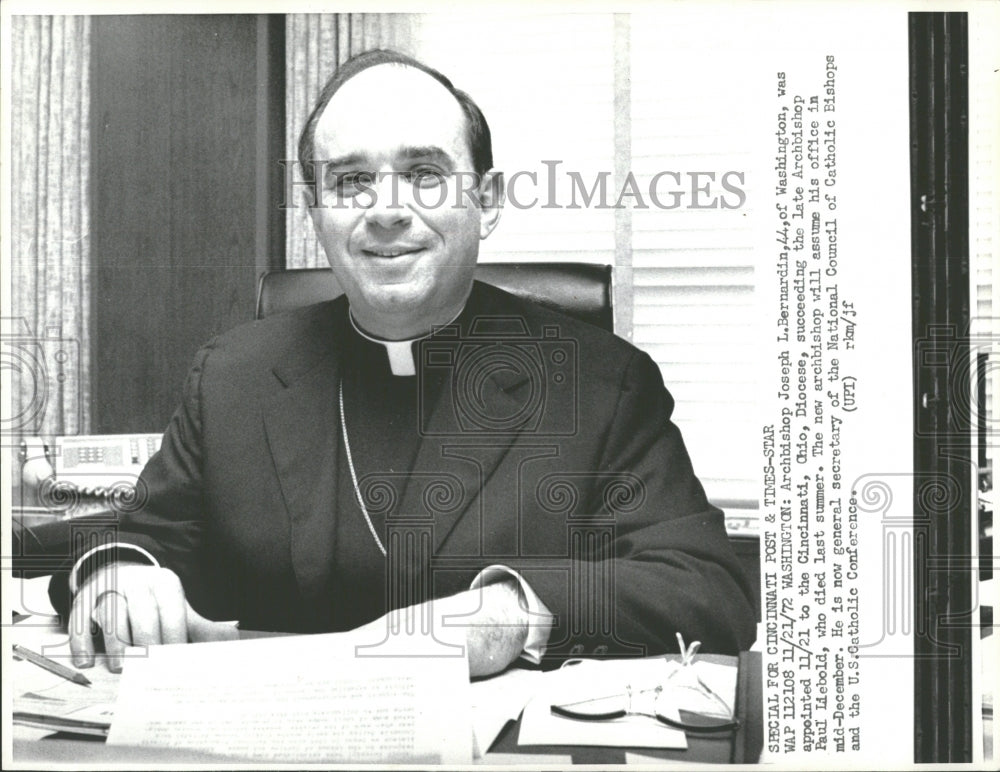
[549,634,740,733]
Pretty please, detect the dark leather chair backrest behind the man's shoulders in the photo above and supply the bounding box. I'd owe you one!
[256,263,614,332]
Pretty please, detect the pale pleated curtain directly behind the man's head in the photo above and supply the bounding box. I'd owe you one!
[285,13,418,268]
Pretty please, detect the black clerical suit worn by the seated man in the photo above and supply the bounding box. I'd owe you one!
[58,283,754,658]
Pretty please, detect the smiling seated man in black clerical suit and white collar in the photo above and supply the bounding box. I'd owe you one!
[53,52,754,675]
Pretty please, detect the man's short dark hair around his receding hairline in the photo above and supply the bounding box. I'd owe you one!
[299,49,493,176]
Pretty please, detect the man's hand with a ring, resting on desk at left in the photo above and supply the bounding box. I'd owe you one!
[69,562,237,673]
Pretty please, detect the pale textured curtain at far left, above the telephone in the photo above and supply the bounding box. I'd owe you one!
[10,16,92,436]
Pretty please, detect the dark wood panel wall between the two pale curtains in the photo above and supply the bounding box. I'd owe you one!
[90,15,284,433]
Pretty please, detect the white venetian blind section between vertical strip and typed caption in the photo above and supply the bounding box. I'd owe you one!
[630,14,759,511]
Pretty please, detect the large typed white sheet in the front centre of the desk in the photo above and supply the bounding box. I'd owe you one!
[108,633,472,764]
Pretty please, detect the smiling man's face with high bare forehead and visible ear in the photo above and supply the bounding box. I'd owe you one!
[310,64,501,339]
